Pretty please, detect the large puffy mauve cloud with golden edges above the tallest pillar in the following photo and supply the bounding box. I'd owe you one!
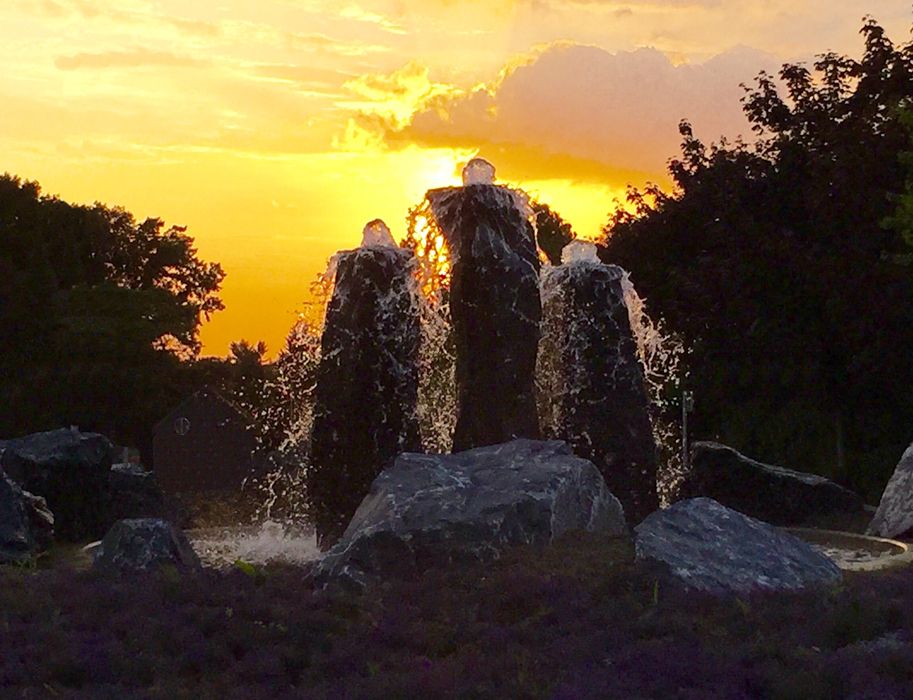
[349,43,777,181]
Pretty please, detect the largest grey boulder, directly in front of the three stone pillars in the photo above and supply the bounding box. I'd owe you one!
[315,439,627,587]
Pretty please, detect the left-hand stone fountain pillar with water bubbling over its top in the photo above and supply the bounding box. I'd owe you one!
[307,220,421,548]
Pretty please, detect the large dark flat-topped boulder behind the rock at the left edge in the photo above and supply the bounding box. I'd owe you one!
[0,429,113,541]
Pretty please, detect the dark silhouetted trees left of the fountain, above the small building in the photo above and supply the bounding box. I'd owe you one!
[0,175,272,462]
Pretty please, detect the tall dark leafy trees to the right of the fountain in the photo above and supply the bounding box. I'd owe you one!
[604,19,913,499]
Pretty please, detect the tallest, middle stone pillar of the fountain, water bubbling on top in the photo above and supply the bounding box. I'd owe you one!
[428,158,542,452]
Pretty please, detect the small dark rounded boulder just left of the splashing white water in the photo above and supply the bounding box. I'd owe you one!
[94,518,200,573]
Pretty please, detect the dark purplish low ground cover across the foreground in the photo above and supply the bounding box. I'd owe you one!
[0,534,913,700]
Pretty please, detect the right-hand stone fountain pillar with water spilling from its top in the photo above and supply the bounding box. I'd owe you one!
[539,241,659,523]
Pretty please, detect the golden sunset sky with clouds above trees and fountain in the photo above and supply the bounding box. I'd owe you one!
[0,0,913,355]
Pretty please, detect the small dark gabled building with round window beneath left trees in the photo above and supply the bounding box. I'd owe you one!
[152,387,258,494]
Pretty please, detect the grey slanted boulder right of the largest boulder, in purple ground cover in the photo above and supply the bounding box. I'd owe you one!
[635,498,842,595]
